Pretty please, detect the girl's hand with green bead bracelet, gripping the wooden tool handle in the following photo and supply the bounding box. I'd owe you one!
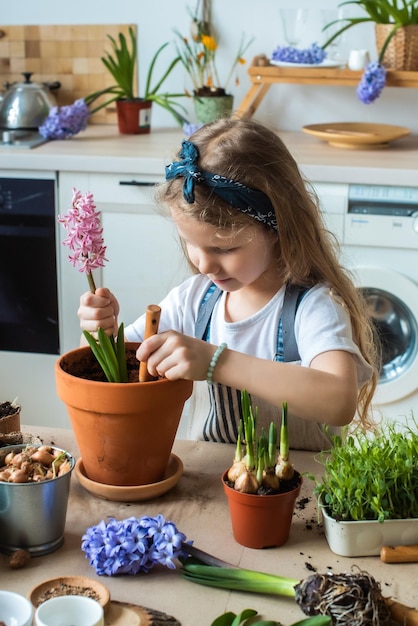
[136,330,216,380]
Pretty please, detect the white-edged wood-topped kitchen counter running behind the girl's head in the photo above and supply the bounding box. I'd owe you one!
[0,125,418,186]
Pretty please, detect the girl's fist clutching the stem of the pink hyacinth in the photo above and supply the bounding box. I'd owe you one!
[77,287,119,335]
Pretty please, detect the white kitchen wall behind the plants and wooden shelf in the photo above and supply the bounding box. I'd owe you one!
[1,0,418,132]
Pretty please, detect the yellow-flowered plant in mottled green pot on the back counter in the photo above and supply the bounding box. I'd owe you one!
[175,4,253,124]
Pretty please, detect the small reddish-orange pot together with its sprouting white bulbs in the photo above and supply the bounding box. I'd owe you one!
[222,390,302,548]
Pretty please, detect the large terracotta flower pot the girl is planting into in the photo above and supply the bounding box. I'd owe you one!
[55,343,193,486]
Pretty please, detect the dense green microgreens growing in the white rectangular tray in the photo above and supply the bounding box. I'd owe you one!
[309,424,418,522]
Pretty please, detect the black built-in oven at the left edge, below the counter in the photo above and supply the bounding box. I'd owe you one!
[0,174,60,354]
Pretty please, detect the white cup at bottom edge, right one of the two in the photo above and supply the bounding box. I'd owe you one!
[35,595,104,626]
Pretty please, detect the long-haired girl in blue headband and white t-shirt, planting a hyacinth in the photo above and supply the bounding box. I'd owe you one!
[78,119,377,450]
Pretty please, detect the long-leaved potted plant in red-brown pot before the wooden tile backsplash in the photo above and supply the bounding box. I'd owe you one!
[95,27,187,134]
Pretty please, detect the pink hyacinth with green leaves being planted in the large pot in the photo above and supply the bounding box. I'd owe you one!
[58,188,128,382]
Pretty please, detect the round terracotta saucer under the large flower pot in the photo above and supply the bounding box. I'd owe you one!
[75,454,183,502]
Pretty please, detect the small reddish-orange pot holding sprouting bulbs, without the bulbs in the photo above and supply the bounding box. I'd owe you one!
[222,471,302,549]
